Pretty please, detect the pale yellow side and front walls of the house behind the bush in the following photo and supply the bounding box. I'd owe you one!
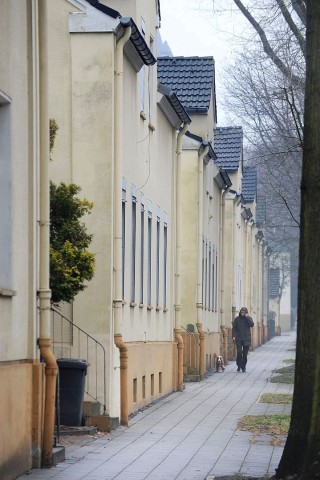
[50,2,176,416]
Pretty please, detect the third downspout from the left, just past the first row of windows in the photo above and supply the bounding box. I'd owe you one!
[174,123,188,392]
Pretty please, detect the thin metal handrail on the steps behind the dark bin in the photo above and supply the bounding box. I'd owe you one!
[51,305,107,414]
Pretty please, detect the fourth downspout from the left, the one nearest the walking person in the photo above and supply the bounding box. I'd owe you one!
[196,144,209,378]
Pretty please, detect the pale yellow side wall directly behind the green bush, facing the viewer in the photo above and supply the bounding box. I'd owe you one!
[50,14,114,412]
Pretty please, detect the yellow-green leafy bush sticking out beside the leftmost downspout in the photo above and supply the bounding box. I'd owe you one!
[50,182,95,303]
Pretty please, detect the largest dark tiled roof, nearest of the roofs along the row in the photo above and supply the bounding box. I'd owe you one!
[157,57,214,114]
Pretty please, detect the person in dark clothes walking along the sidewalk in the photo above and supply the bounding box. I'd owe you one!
[232,307,254,372]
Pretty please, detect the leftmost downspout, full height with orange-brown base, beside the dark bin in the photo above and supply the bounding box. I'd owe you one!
[38,0,58,467]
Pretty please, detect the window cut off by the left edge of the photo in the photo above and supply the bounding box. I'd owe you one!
[0,90,13,290]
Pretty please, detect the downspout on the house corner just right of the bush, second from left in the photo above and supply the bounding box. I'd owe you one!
[113,25,131,425]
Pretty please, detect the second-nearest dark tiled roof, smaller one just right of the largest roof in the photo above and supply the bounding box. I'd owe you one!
[214,127,243,172]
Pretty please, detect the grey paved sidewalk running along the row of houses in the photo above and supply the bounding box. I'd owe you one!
[19,332,296,480]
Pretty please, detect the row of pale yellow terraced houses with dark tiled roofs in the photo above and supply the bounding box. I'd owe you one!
[0,0,286,479]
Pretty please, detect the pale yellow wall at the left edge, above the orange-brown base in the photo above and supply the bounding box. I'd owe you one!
[0,1,37,361]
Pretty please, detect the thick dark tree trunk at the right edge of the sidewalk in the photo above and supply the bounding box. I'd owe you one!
[276,0,320,480]
